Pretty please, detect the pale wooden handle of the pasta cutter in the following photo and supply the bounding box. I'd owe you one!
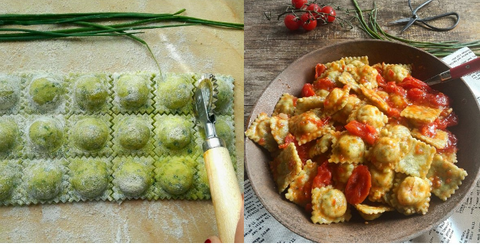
[203,147,243,243]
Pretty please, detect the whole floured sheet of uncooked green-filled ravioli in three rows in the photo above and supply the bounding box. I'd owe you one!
[0,72,236,205]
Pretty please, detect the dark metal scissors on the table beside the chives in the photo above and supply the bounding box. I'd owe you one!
[389,0,460,33]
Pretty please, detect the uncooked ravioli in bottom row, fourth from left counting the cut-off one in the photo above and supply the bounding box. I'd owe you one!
[112,157,155,202]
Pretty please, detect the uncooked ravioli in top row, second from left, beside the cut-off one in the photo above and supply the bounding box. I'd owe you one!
[22,73,70,114]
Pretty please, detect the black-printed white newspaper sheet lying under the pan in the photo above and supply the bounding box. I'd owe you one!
[244,48,480,243]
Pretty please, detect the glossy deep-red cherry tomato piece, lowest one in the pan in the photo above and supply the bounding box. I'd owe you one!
[345,165,372,205]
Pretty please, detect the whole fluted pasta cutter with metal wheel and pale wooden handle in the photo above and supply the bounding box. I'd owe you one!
[194,74,243,243]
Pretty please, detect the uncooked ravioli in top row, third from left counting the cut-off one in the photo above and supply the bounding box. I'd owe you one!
[67,74,112,114]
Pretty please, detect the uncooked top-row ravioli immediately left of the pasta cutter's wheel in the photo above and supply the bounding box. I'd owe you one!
[154,73,196,115]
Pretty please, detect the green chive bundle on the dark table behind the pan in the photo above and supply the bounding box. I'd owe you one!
[352,0,480,57]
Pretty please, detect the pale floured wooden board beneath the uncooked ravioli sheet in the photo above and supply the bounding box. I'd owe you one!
[0,0,244,243]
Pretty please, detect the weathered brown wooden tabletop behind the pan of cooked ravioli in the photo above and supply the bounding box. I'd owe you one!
[244,0,480,178]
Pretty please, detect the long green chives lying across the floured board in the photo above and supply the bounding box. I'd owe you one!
[0,9,244,70]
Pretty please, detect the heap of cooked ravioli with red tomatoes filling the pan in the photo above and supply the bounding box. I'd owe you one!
[245,56,467,224]
